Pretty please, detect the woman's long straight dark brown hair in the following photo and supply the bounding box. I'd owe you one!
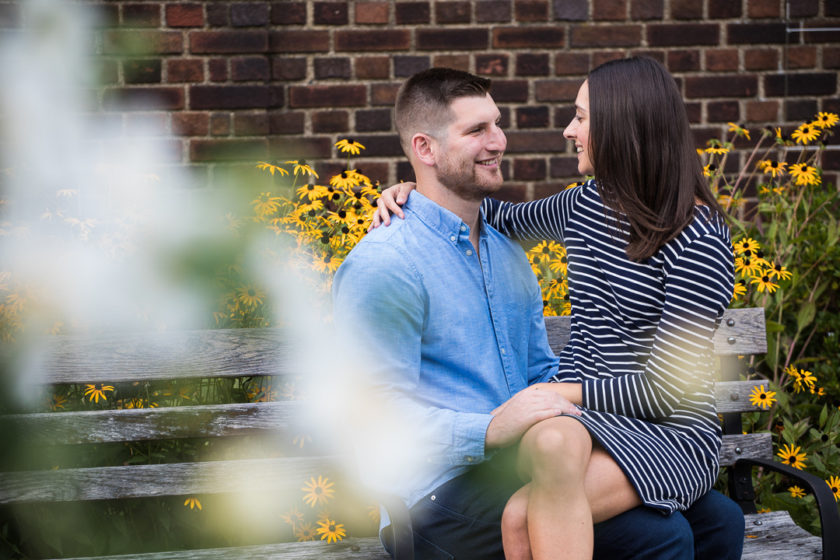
[588,57,725,261]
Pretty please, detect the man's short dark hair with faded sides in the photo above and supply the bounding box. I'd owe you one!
[394,68,490,157]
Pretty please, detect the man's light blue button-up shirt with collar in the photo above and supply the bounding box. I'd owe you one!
[333,191,557,507]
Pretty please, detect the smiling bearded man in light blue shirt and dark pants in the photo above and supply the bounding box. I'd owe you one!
[333,68,741,559]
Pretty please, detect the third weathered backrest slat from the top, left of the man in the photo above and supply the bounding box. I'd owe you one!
[0,456,346,503]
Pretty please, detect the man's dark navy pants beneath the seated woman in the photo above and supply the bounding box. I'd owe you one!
[382,454,744,560]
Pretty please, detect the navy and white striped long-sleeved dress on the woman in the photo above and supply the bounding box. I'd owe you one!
[483,180,734,513]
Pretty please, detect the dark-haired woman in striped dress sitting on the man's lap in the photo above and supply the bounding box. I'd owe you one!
[377,57,734,558]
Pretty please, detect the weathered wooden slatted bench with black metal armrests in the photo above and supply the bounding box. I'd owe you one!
[0,308,840,560]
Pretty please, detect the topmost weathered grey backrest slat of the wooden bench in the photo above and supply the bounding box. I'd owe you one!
[31,308,767,384]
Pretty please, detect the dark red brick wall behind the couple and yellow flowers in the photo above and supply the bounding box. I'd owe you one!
[0,0,840,199]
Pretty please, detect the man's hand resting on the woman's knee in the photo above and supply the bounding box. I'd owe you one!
[484,384,580,449]
